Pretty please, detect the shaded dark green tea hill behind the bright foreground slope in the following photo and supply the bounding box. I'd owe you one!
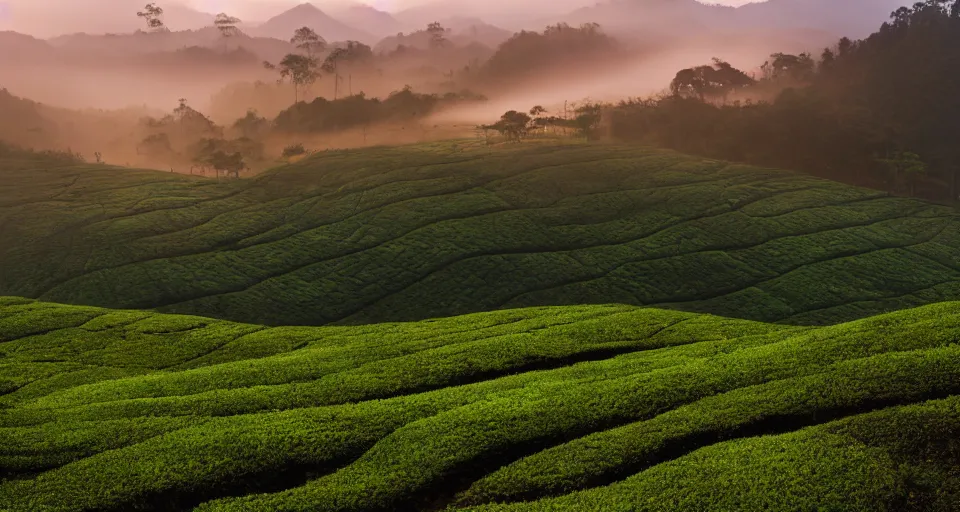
[0,142,960,325]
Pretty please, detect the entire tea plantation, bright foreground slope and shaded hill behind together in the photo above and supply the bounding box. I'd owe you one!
[0,141,960,512]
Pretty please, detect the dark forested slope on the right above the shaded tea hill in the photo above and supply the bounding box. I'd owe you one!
[610,0,960,200]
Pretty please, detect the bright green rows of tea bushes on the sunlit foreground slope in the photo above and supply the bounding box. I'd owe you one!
[0,298,960,511]
